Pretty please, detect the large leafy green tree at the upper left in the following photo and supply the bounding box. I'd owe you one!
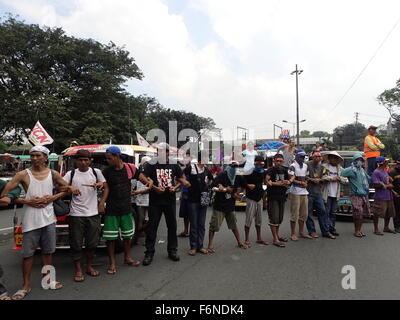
[0,16,143,150]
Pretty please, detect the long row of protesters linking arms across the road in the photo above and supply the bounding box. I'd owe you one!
[0,128,400,300]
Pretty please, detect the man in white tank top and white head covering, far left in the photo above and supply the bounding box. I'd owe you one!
[2,146,68,300]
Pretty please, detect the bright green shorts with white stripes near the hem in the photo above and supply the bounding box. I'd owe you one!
[103,213,135,241]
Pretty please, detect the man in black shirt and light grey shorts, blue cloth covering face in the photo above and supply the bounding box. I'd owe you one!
[242,156,268,248]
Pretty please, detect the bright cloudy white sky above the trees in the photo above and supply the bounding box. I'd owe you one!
[0,0,400,138]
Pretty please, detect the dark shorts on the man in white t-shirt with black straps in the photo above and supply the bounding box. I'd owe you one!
[68,215,101,260]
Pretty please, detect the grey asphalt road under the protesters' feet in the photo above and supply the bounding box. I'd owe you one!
[0,205,400,300]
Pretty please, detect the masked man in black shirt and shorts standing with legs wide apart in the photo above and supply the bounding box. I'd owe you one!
[207,158,247,253]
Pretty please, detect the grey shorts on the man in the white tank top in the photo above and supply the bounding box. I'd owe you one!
[22,223,56,258]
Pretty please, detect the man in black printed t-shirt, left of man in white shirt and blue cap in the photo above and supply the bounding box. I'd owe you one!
[265,154,291,248]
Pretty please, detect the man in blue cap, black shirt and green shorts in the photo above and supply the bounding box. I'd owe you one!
[99,146,153,274]
